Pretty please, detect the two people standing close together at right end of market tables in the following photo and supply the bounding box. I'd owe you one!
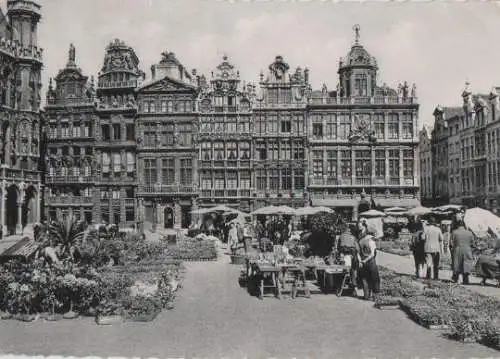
[336,220,380,300]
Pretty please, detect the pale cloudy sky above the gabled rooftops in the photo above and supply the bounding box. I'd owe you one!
[0,0,500,126]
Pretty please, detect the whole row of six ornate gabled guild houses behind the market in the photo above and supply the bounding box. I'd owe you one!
[46,27,419,229]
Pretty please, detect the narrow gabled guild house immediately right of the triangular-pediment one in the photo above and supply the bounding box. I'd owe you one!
[198,56,255,211]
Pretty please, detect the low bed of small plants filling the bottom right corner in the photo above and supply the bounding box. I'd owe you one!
[375,268,500,349]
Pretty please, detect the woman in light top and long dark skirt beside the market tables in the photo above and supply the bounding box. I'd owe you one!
[359,223,380,300]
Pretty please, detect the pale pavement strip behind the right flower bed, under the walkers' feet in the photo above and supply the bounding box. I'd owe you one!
[377,251,500,298]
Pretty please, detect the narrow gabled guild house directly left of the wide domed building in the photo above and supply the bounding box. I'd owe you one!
[252,56,310,209]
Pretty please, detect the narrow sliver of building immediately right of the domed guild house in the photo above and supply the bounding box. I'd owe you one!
[418,126,433,206]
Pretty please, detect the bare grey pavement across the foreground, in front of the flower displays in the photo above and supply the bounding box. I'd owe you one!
[0,249,500,358]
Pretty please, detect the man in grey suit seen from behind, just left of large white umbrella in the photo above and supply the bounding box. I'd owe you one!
[451,220,474,284]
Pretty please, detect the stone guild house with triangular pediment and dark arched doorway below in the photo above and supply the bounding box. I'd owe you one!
[136,52,199,229]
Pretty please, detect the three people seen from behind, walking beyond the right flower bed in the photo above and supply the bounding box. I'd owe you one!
[410,214,475,284]
